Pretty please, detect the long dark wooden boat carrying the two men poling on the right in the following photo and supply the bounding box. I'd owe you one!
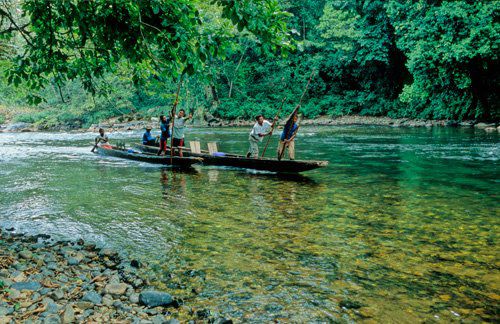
[132,144,328,173]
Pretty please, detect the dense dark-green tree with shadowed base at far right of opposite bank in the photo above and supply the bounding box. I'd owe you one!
[387,0,500,119]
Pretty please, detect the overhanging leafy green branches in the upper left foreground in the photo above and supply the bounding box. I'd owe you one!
[1,0,291,101]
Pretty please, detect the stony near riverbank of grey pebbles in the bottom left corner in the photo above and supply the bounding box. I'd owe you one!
[0,229,230,323]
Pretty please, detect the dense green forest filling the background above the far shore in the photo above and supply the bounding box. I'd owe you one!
[0,0,500,127]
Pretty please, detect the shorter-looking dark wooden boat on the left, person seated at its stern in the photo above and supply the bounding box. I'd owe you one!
[97,145,203,168]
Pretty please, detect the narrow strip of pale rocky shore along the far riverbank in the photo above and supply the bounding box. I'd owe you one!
[0,115,500,132]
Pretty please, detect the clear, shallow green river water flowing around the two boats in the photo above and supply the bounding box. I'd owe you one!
[0,127,500,323]
